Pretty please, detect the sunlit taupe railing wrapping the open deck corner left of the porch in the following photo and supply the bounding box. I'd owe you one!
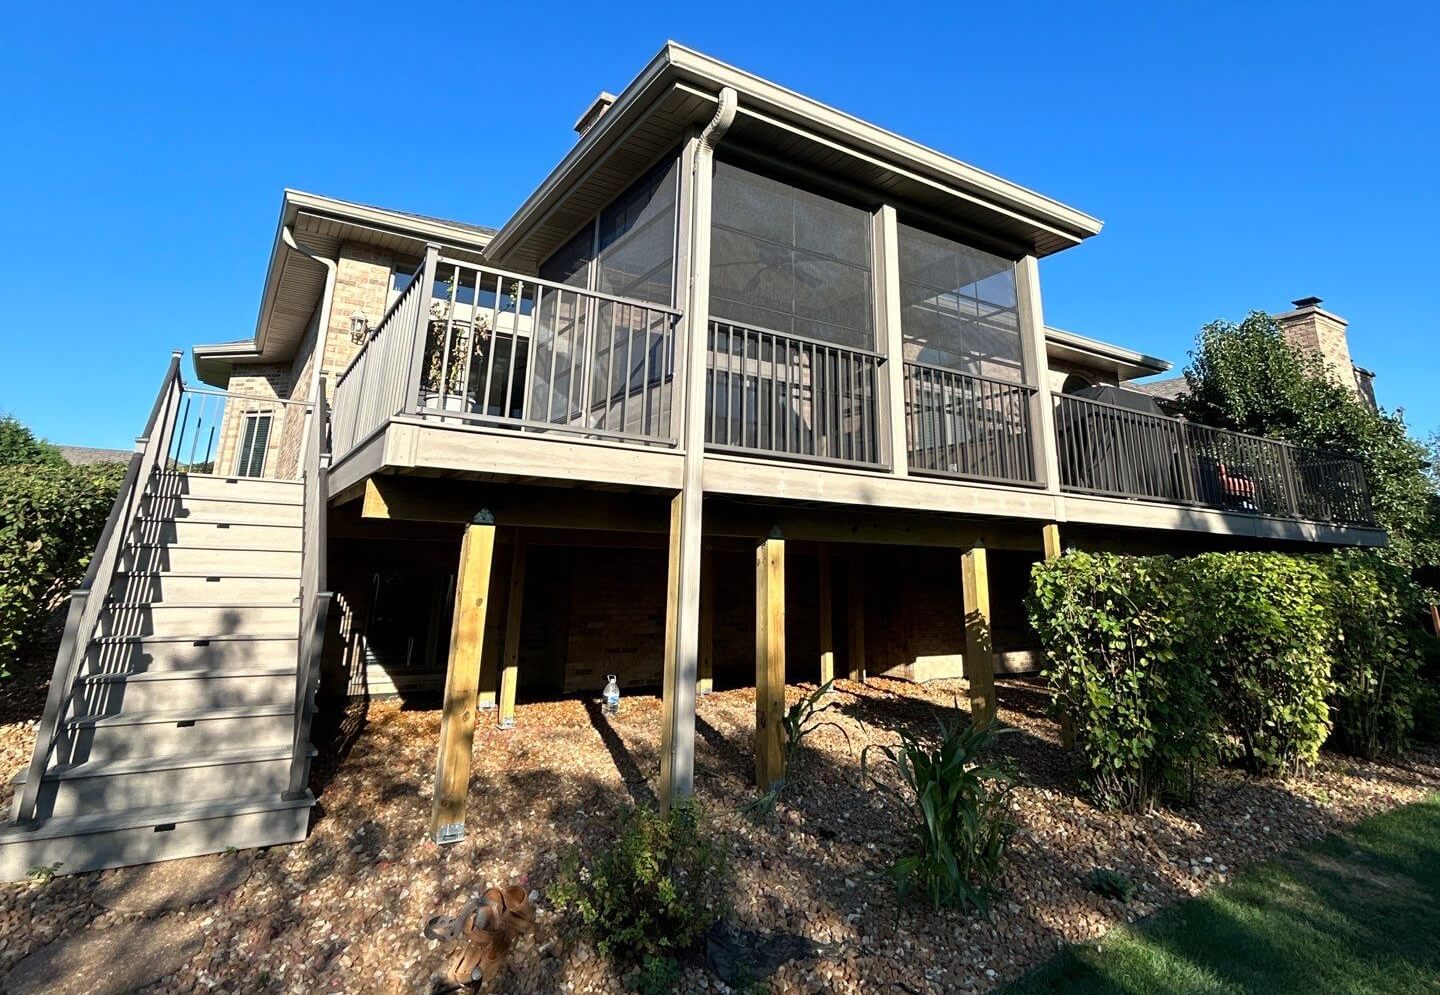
[334,253,680,459]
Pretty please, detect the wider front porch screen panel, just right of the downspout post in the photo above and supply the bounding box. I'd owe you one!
[710,163,874,348]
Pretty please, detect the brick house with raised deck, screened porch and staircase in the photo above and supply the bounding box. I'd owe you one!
[0,45,1384,877]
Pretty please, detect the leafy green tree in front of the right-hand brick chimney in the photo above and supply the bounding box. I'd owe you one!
[1181,311,1440,578]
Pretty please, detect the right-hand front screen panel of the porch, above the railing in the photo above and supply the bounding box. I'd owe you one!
[899,225,1024,383]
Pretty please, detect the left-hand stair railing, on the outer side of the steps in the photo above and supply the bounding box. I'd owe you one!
[14,351,181,827]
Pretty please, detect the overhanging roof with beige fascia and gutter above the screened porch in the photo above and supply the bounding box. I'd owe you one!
[487,42,1100,269]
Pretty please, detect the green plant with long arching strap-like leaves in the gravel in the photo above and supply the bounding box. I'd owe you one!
[860,719,1015,911]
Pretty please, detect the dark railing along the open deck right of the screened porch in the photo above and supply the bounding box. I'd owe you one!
[1056,395,1374,526]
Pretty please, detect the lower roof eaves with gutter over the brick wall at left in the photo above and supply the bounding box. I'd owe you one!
[192,189,495,386]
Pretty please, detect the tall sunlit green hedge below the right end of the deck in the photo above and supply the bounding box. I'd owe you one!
[1027,551,1433,808]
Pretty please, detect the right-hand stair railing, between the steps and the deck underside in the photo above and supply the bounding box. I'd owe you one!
[285,374,334,801]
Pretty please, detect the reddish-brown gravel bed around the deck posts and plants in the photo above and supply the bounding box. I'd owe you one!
[0,662,1440,994]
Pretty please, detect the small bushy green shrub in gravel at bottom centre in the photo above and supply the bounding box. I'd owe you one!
[549,803,727,963]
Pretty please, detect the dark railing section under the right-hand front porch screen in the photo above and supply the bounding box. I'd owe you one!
[904,363,1035,484]
